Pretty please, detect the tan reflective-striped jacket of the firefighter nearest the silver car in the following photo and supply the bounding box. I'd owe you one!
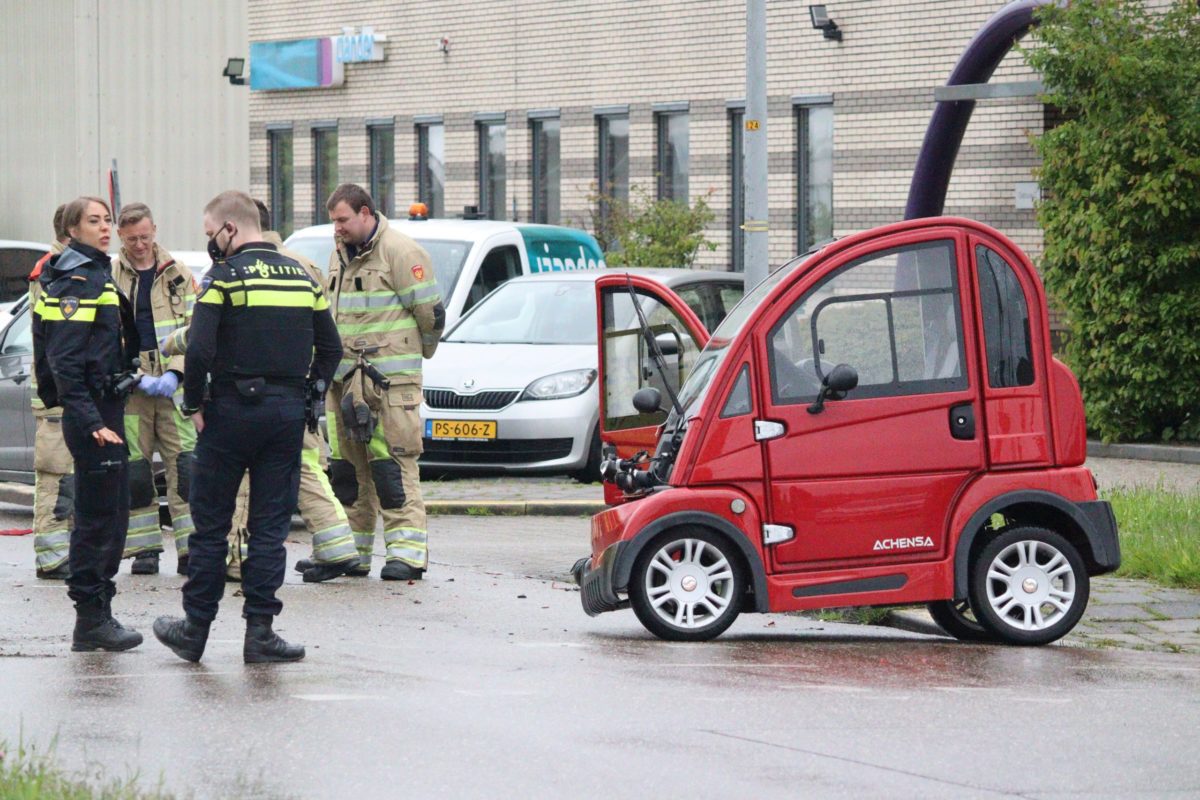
[329,213,445,386]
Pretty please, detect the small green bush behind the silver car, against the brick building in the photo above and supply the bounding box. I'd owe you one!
[589,186,716,267]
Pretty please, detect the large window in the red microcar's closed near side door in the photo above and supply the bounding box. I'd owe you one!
[768,241,967,403]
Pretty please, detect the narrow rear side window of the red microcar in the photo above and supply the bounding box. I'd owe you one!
[976,245,1033,389]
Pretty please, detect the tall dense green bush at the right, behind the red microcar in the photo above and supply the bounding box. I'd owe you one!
[1026,0,1200,441]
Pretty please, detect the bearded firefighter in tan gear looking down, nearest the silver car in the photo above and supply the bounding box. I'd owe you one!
[325,184,445,581]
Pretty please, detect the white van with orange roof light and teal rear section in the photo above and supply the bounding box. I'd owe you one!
[283,217,606,329]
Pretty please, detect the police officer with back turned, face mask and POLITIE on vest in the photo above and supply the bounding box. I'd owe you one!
[154,191,342,663]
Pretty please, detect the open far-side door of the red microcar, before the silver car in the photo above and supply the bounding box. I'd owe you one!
[596,272,708,504]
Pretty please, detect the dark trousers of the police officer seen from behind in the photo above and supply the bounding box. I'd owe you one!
[184,391,305,621]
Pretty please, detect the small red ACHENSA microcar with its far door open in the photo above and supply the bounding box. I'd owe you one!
[574,217,1121,644]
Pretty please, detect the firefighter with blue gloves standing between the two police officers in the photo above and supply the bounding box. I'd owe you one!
[113,203,196,575]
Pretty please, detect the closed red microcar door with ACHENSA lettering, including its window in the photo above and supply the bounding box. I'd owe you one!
[754,227,985,575]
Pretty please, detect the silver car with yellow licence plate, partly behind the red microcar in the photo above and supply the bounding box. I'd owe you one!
[421,269,743,482]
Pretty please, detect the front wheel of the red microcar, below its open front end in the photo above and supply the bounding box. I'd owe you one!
[629,528,746,642]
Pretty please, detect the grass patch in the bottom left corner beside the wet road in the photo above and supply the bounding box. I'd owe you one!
[0,741,173,800]
